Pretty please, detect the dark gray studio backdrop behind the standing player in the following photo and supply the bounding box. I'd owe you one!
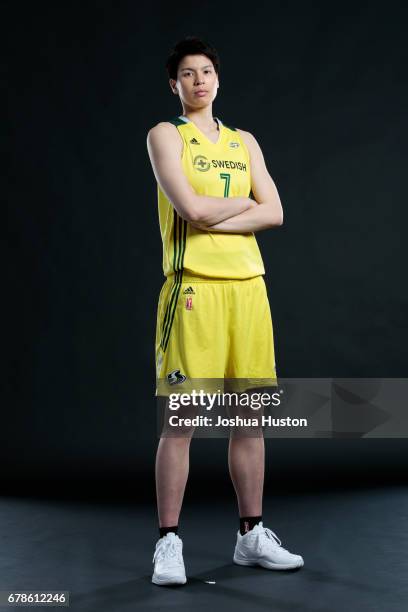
[1,2,408,499]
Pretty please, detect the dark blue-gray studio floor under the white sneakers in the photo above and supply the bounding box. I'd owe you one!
[0,486,408,612]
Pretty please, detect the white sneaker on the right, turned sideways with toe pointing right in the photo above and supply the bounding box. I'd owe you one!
[233,521,304,569]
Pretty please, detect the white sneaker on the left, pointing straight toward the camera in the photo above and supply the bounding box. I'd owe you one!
[152,531,187,585]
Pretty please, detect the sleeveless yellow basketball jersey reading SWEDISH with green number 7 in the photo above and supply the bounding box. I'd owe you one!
[157,116,265,280]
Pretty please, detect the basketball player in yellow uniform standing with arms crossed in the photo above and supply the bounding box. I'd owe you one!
[147,37,304,585]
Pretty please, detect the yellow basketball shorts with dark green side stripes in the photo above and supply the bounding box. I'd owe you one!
[155,274,277,396]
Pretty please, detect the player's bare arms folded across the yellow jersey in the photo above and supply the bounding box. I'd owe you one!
[147,123,283,233]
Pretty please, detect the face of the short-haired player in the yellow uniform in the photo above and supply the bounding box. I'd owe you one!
[170,55,219,108]
